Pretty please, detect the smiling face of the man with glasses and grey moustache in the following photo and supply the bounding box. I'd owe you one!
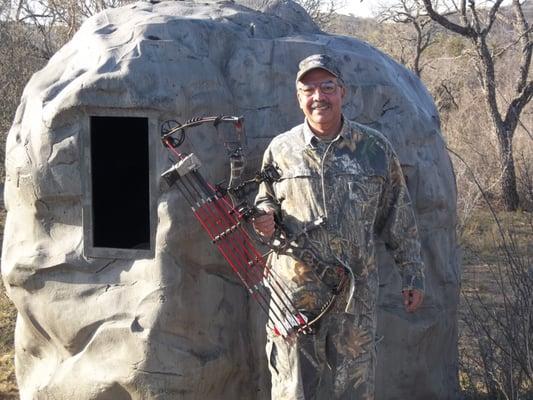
[297,68,345,132]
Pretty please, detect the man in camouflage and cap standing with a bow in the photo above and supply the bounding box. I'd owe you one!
[254,55,424,400]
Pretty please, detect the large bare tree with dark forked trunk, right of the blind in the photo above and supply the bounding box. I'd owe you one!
[422,0,533,211]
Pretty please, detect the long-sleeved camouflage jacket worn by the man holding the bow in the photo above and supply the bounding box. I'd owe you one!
[256,119,424,316]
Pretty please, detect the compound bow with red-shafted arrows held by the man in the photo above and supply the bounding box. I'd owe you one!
[161,116,346,337]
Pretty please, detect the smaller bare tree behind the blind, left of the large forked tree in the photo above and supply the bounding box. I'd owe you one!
[378,0,437,77]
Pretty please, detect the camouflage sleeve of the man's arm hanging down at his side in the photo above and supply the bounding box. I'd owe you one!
[377,150,425,291]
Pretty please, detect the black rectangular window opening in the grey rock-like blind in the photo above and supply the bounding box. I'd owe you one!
[90,116,150,249]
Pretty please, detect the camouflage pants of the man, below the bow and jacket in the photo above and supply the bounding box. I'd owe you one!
[266,285,376,400]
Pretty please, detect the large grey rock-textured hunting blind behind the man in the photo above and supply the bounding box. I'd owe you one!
[2,1,459,400]
